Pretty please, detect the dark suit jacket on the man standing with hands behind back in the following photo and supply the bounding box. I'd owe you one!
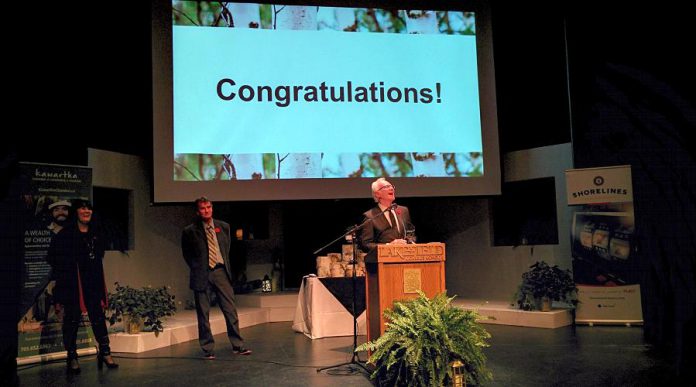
[181,219,232,291]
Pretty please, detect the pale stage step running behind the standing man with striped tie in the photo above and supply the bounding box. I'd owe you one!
[109,291,298,353]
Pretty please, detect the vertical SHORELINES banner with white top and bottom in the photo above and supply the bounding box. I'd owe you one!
[566,165,643,324]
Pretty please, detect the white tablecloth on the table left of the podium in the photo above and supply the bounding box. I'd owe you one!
[292,276,367,339]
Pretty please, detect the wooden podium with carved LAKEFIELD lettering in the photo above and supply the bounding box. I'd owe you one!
[365,243,445,341]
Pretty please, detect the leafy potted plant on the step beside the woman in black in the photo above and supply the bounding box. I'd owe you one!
[107,282,176,336]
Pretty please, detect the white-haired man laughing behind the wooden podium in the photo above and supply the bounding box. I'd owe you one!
[360,177,415,253]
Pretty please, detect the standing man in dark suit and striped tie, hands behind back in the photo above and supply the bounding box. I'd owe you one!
[181,197,251,360]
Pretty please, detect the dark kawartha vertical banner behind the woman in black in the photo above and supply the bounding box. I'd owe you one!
[17,163,94,358]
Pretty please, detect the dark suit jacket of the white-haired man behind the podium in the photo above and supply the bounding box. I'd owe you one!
[360,206,411,253]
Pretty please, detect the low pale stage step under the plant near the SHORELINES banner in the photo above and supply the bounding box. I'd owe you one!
[452,298,573,328]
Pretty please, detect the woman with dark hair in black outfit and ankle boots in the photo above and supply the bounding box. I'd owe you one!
[47,200,118,373]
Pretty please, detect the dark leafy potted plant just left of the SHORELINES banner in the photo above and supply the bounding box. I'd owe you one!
[515,261,578,312]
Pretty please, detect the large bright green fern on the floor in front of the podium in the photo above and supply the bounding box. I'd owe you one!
[356,292,492,386]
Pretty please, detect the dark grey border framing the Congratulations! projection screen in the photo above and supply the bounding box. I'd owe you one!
[152,0,501,203]
